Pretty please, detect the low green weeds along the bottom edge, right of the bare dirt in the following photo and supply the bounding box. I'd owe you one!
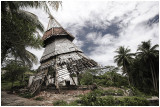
[53,90,149,106]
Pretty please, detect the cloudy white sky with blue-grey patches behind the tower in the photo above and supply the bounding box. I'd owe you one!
[26,1,159,69]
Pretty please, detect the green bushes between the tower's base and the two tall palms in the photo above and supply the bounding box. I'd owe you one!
[80,66,128,87]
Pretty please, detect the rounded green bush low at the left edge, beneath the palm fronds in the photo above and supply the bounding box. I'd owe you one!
[1,60,35,90]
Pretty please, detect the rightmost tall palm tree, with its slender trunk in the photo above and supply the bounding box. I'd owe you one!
[137,40,159,92]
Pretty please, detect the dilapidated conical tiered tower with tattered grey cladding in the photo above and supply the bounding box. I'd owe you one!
[28,17,98,93]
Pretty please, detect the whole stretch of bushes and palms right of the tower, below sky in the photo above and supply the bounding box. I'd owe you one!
[80,40,159,96]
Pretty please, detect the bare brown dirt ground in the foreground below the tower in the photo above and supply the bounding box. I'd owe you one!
[1,90,90,106]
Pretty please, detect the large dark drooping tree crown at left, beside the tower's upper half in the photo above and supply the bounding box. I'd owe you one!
[1,11,44,62]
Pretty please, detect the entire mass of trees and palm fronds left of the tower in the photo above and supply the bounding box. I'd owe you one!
[1,1,61,93]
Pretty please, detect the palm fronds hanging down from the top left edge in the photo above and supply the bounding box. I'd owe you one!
[1,1,62,15]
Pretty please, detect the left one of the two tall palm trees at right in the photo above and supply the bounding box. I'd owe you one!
[114,46,134,85]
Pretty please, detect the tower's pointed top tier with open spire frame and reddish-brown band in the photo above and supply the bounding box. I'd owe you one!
[42,16,74,41]
